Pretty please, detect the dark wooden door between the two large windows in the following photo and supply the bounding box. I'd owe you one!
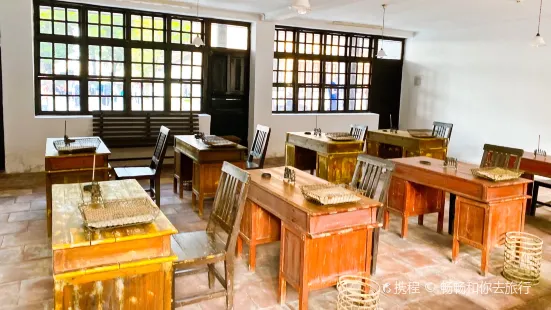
[206,50,249,146]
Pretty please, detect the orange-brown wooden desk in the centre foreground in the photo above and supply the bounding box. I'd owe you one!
[237,167,382,309]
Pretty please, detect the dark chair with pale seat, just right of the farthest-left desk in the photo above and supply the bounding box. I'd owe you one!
[114,126,170,207]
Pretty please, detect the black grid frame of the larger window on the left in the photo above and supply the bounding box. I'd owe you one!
[33,0,251,116]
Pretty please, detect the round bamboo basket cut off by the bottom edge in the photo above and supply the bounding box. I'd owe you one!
[337,273,381,310]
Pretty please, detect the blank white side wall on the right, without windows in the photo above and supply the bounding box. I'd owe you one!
[400,20,551,163]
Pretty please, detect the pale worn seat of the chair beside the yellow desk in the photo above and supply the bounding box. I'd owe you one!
[170,231,226,268]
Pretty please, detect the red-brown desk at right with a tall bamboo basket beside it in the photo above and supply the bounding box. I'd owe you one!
[385,157,531,275]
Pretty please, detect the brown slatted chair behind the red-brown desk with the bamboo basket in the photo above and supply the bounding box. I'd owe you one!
[448,144,524,235]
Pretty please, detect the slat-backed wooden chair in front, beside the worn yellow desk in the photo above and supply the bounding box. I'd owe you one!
[171,162,250,309]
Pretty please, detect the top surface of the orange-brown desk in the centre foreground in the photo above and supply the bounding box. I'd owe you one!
[249,167,382,216]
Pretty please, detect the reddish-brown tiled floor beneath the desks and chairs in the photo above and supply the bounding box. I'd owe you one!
[0,167,551,310]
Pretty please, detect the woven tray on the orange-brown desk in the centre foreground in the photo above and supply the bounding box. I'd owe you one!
[300,184,361,205]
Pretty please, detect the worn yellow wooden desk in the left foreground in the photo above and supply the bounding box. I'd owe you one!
[52,180,177,310]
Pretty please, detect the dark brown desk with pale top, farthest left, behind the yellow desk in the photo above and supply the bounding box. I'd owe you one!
[45,137,111,236]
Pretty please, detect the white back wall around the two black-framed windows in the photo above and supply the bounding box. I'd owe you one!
[0,0,398,173]
